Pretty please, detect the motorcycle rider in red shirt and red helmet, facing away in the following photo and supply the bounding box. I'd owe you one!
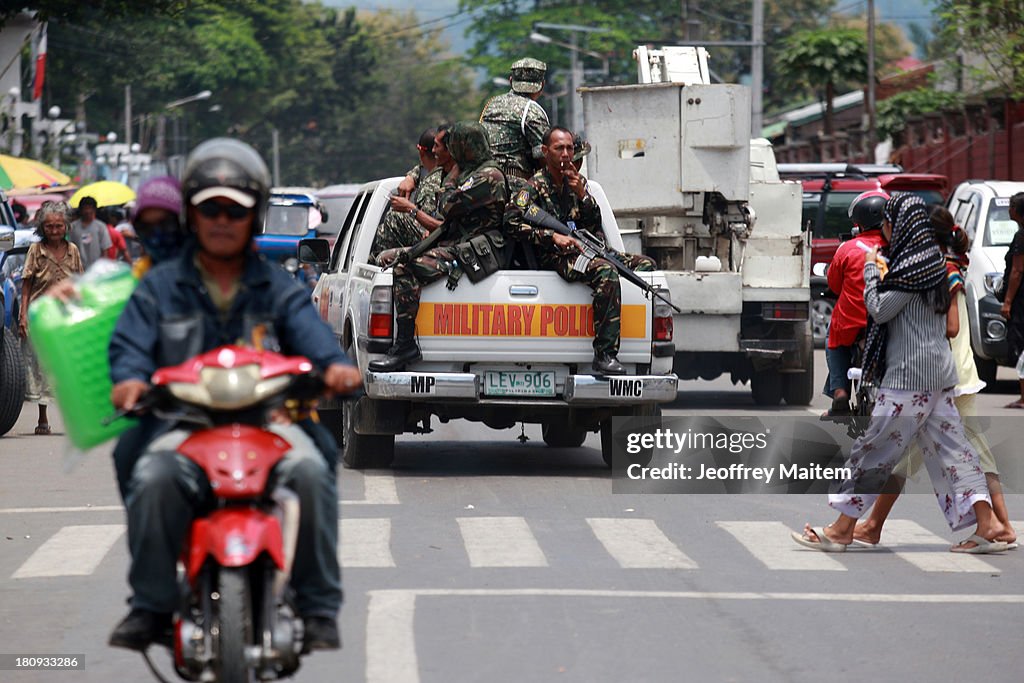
[824,189,889,415]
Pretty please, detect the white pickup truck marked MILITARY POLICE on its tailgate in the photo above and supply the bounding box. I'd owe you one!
[299,178,677,468]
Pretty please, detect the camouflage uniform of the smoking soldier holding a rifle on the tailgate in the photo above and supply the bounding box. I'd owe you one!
[506,168,655,355]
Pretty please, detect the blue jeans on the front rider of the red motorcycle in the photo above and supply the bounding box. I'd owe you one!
[125,425,342,618]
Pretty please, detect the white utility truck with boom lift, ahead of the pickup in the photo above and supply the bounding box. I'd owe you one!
[581,47,814,405]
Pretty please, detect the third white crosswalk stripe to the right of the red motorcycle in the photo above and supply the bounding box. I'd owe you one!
[587,517,697,569]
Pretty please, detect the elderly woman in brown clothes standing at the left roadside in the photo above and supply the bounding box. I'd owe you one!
[20,202,82,434]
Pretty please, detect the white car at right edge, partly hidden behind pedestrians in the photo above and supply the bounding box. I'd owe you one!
[947,180,1024,385]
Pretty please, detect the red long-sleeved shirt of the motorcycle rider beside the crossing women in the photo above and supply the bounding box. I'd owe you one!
[827,230,888,348]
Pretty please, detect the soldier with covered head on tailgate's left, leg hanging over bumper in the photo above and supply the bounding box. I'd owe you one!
[370,122,508,372]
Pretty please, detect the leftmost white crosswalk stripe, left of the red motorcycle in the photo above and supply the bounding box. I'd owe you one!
[11,524,125,579]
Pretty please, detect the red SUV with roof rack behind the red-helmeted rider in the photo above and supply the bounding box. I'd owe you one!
[794,164,949,346]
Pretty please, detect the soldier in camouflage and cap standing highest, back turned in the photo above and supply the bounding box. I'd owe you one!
[480,57,551,179]
